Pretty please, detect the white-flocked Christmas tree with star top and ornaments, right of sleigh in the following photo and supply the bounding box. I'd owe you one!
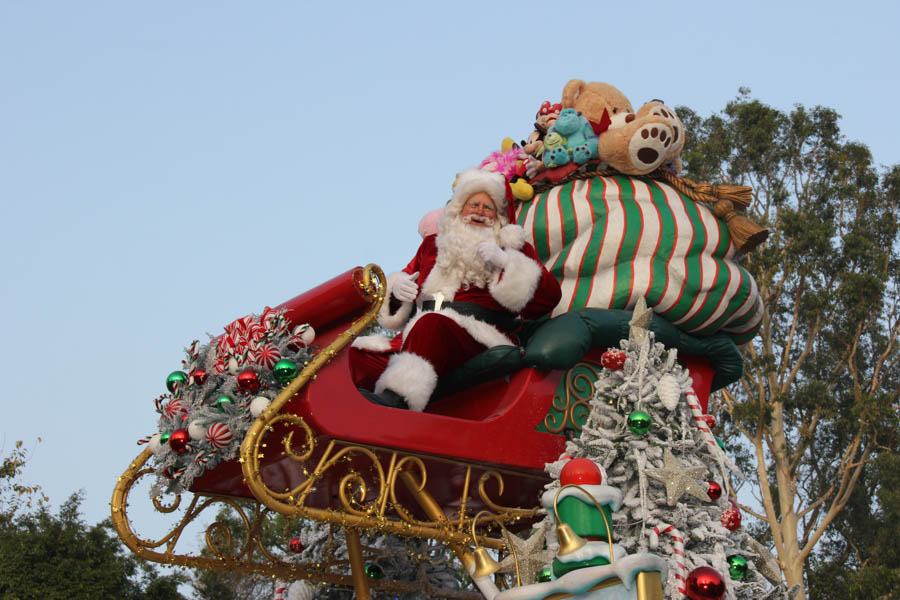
[545,302,787,600]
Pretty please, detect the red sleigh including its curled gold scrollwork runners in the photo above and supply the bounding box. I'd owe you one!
[111,266,739,598]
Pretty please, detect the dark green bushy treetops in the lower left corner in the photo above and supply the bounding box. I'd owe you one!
[0,494,184,600]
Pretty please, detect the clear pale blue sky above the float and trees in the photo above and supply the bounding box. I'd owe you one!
[0,0,900,548]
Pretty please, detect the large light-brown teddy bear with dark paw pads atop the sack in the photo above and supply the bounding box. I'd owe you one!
[562,79,684,175]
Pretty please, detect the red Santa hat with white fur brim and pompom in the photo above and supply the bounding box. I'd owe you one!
[443,169,525,250]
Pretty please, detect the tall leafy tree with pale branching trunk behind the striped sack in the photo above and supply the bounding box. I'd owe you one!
[678,89,900,600]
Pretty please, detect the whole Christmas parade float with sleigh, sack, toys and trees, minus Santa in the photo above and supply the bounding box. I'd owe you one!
[111,80,780,600]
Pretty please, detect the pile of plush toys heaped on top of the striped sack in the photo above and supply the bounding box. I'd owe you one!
[480,79,685,200]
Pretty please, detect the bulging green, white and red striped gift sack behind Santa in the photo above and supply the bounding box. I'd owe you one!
[517,176,763,344]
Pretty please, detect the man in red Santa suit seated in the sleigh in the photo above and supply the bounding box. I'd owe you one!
[350,169,560,411]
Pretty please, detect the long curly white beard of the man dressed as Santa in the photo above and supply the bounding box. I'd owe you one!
[422,217,500,299]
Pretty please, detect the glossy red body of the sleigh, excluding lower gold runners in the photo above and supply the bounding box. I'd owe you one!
[191,268,714,519]
